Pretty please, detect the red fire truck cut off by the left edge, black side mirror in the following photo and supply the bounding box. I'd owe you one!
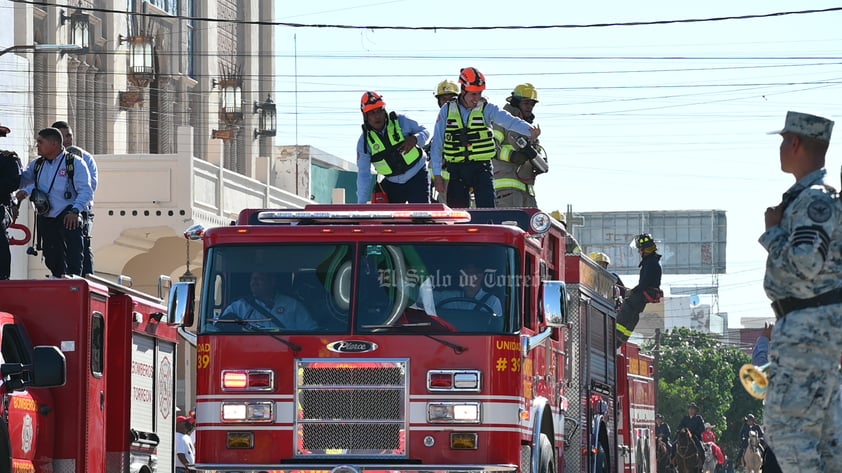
[0,277,177,473]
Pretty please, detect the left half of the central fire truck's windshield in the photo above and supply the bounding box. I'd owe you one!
[200,244,352,334]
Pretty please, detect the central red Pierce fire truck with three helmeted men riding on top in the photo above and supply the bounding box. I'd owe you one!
[170,204,656,473]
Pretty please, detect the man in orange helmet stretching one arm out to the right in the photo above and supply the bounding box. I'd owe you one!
[430,67,541,208]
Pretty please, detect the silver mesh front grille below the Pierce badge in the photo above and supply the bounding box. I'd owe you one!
[295,358,408,458]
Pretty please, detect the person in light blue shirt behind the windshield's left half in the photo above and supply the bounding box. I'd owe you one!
[218,272,318,330]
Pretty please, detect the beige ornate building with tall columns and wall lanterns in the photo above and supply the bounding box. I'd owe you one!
[0,0,318,294]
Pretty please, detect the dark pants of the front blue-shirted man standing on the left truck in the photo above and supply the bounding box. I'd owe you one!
[38,213,84,277]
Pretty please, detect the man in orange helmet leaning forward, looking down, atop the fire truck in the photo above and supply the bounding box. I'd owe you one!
[357,91,430,204]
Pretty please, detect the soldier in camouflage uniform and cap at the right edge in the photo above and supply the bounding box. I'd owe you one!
[759,112,842,472]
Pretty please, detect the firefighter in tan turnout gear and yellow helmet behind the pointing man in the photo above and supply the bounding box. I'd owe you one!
[494,83,547,207]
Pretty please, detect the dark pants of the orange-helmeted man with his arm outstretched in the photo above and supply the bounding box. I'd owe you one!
[447,161,497,209]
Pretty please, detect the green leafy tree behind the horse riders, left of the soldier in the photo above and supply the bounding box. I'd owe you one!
[646,328,763,458]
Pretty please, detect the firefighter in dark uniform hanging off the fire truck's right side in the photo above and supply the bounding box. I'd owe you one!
[617,233,660,346]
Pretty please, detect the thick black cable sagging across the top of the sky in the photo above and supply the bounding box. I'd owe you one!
[13,0,842,31]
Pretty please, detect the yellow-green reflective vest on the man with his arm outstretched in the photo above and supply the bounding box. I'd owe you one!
[442,102,497,163]
